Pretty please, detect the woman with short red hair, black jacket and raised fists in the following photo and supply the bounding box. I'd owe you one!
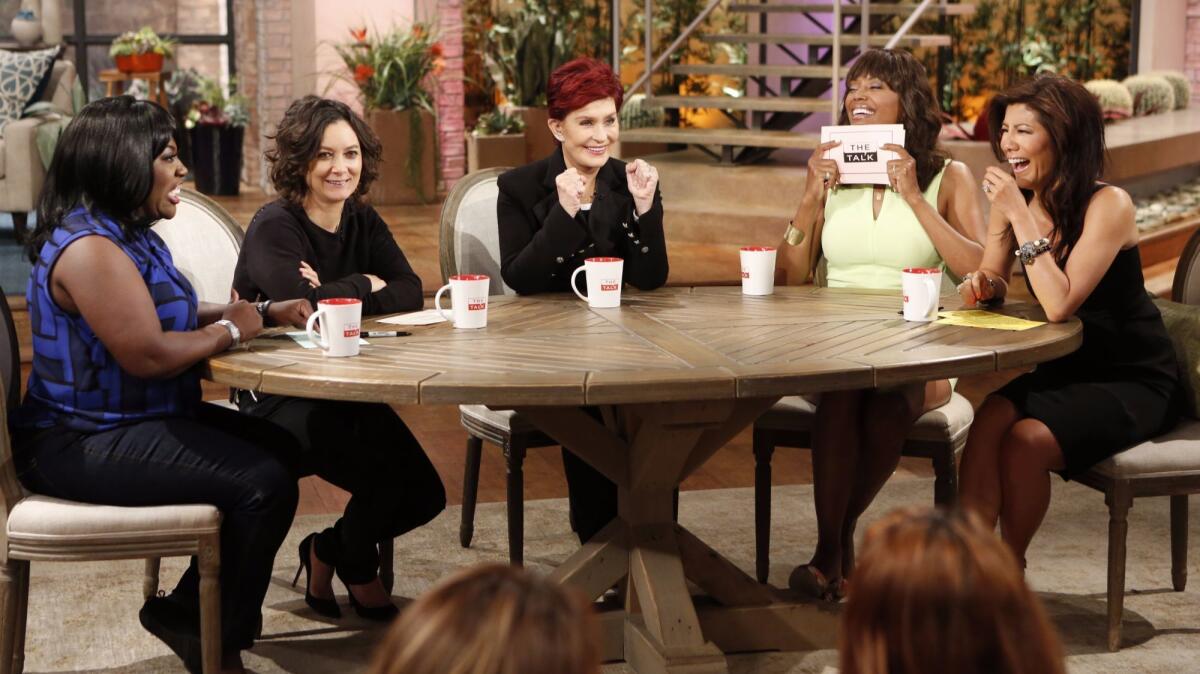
[497,59,667,541]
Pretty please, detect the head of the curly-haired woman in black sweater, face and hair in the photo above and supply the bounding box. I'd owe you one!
[264,96,383,205]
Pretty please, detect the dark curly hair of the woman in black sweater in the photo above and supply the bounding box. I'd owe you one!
[264,96,383,204]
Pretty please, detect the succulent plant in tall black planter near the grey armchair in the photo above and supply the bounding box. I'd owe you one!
[184,76,250,197]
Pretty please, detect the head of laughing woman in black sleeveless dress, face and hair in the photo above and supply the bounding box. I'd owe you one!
[988,73,1105,263]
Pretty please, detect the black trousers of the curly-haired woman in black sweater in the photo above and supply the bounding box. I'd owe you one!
[238,391,446,584]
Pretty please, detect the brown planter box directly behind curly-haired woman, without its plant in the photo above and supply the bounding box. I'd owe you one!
[366,110,438,206]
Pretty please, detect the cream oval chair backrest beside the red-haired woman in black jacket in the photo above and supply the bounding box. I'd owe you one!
[438,168,516,295]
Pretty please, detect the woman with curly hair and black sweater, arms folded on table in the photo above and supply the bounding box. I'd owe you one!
[234,96,445,620]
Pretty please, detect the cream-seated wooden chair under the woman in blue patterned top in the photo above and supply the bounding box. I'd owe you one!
[0,288,221,674]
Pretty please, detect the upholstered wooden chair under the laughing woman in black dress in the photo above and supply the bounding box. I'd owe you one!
[1075,231,1200,651]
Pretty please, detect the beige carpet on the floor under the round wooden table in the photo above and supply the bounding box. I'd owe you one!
[16,480,1200,674]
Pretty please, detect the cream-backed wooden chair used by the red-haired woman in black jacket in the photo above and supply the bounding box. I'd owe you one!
[439,168,558,565]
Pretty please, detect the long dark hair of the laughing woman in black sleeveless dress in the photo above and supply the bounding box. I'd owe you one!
[988,73,1108,265]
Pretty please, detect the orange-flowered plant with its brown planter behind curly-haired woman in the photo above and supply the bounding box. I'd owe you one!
[335,23,444,205]
